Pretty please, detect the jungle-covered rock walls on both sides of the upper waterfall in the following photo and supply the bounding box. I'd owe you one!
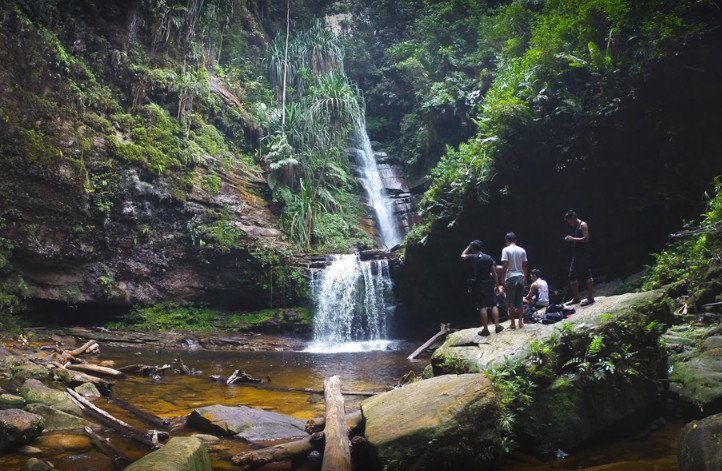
[0,0,722,332]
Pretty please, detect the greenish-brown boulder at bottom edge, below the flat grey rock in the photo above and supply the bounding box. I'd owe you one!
[125,437,213,471]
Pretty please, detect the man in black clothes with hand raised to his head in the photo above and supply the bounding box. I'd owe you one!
[461,240,504,336]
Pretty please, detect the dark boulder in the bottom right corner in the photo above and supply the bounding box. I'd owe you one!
[677,414,722,471]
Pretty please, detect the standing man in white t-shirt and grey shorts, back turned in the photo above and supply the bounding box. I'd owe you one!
[501,232,527,329]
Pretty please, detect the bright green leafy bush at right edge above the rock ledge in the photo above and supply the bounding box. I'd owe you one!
[643,179,722,289]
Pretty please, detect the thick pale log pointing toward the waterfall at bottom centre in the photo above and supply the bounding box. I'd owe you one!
[321,376,351,471]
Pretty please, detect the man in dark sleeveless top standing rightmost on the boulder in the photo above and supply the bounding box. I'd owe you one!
[564,209,594,306]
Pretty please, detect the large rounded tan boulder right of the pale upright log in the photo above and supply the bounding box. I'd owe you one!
[361,374,500,470]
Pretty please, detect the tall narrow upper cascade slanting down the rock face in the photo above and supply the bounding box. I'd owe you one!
[354,122,401,249]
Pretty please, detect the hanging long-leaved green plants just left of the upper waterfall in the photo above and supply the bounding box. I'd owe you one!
[265,23,368,249]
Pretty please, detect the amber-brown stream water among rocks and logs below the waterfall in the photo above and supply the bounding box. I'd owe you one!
[0,345,681,471]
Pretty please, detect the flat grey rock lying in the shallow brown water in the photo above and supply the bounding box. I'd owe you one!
[187,404,308,442]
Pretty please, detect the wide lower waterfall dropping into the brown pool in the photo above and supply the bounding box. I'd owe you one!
[306,254,392,353]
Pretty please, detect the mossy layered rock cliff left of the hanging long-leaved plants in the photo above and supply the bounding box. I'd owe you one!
[0,0,304,318]
